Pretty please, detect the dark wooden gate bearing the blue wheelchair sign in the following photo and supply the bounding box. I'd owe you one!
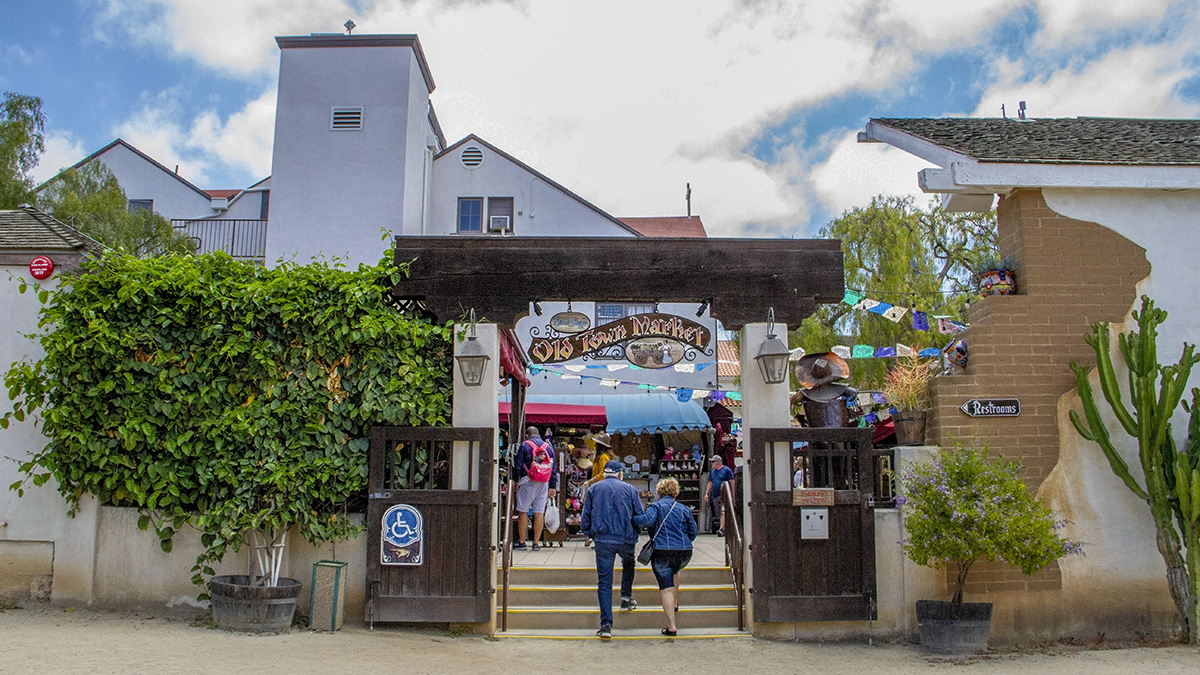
[366,426,494,623]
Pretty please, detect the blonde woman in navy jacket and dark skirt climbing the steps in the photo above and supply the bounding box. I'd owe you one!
[634,478,696,635]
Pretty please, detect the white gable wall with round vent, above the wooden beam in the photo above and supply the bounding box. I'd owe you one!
[427,141,634,236]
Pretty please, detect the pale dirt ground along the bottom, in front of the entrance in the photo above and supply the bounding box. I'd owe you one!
[0,604,1200,675]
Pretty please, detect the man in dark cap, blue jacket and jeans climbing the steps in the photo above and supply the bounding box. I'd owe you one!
[581,460,642,638]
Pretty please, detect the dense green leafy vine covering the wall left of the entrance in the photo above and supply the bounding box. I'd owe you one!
[0,251,454,584]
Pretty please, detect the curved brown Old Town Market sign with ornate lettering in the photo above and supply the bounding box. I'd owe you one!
[528,312,712,368]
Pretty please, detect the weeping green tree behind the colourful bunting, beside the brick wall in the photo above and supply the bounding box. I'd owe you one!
[792,196,996,388]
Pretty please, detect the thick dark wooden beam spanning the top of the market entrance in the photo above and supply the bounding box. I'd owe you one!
[392,237,845,329]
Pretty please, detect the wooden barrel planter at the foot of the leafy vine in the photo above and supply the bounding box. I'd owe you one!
[209,574,300,633]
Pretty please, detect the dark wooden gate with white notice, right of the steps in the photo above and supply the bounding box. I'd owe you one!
[750,428,875,621]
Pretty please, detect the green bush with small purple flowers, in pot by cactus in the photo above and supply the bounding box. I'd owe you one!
[900,444,1084,603]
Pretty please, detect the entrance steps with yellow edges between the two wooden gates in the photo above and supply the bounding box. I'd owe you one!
[497,560,750,640]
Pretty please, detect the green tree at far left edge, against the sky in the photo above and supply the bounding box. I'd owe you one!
[0,91,46,209]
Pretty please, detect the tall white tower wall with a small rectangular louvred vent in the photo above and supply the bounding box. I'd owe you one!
[266,42,428,265]
